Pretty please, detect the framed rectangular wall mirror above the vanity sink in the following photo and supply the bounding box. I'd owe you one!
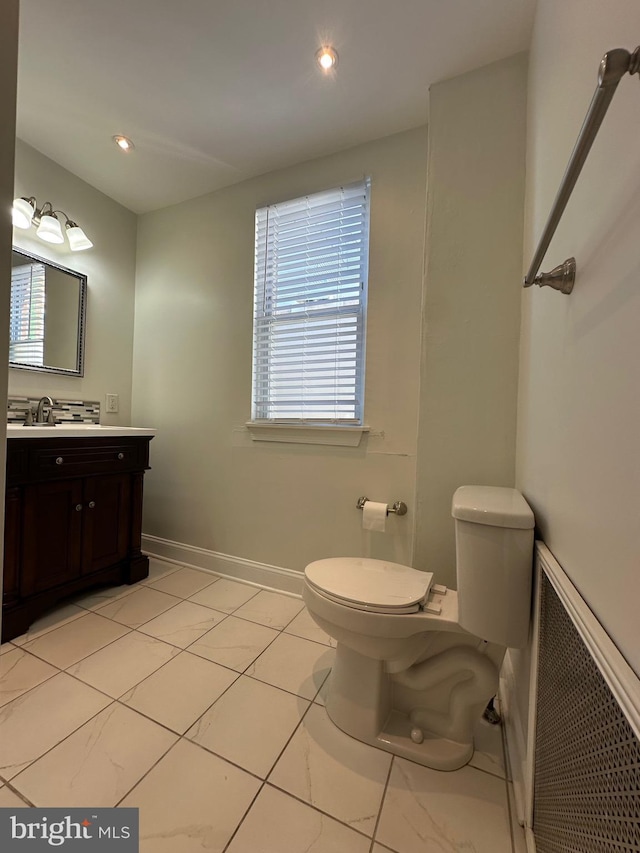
[9,249,87,376]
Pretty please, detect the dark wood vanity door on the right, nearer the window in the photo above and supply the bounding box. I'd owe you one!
[82,474,131,574]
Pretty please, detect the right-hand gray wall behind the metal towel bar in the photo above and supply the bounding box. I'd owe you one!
[517,0,640,680]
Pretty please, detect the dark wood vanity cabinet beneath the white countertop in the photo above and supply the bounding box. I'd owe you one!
[2,436,151,642]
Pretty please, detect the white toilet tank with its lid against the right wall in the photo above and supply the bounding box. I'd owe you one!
[451,486,534,648]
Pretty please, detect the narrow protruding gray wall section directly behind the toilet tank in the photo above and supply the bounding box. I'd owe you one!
[415,54,526,587]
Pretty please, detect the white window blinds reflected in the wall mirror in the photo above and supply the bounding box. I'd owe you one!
[9,264,45,367]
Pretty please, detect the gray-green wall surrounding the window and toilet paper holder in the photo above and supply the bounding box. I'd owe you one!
[133,128,426,570]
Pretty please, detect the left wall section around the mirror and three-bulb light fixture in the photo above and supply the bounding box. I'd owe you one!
[9,140,137,424]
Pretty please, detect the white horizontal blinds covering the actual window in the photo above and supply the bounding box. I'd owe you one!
[252,179,369,424]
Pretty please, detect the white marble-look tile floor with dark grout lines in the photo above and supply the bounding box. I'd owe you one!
[0,558,522,853]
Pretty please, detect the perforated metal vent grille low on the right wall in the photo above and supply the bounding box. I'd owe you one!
[533,573,640,853]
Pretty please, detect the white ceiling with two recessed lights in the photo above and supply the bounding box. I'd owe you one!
[18,0,535,213]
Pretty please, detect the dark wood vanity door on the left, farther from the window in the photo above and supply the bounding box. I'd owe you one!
[20,480,85,596]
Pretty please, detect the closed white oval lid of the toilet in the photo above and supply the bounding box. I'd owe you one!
[304,557,433,613]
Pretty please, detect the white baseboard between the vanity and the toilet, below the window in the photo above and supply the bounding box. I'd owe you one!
[142,533,304,596]
